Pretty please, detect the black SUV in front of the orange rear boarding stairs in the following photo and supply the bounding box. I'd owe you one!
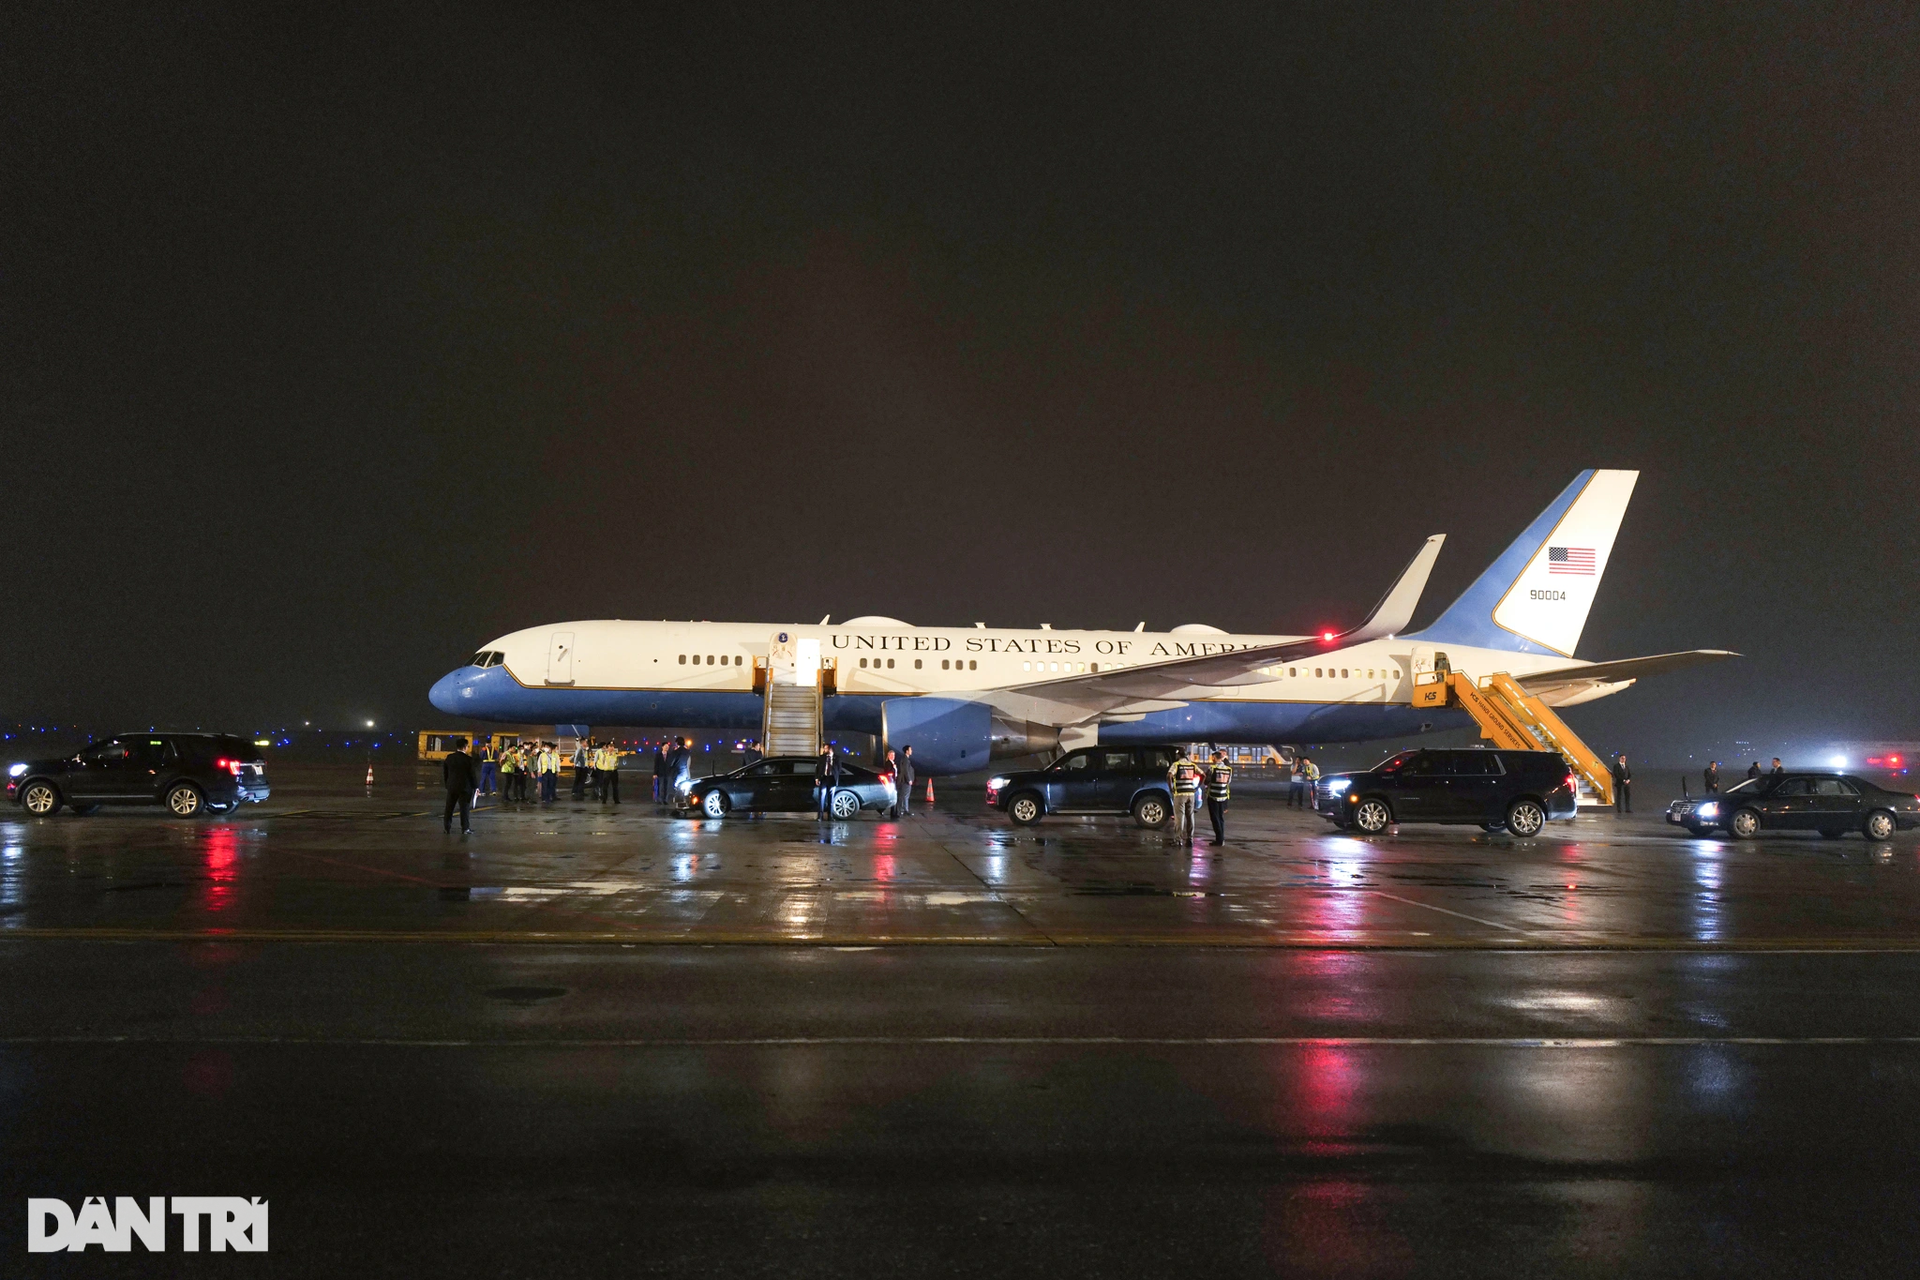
[1313,747,1578,835]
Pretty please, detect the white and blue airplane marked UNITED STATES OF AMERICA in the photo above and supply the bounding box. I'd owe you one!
[428,470,1738,775]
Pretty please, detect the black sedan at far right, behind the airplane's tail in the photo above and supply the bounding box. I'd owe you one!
[1667,773,1920,841]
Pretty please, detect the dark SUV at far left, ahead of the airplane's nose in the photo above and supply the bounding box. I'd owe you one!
[6,733,269,818]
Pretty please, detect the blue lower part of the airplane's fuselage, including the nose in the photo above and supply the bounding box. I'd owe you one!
[430,666,1473,771]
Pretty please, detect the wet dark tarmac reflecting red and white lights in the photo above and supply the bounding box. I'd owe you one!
[0,770,1920,1276]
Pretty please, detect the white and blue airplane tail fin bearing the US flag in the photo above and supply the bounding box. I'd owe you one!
[1413,470,1640,656]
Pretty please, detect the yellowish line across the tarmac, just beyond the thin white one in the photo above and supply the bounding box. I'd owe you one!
[0,925,1920,956]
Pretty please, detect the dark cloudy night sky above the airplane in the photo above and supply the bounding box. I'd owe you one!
[0,4,1920,758]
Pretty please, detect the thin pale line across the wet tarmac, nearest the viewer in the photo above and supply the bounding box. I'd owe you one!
[0,1034,1920,1050]
